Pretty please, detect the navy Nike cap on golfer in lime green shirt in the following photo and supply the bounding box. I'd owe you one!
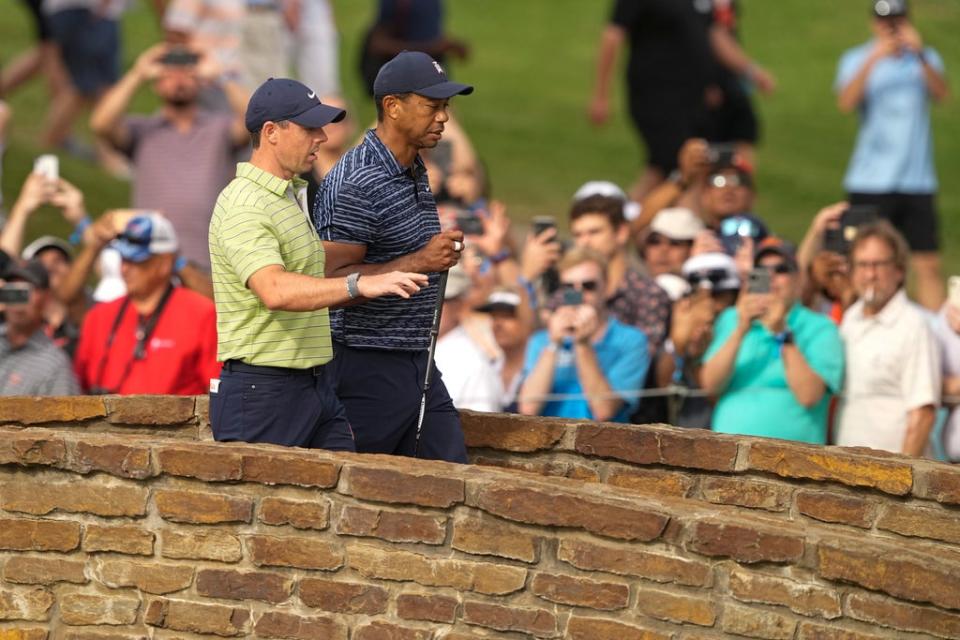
[245,78,347,132]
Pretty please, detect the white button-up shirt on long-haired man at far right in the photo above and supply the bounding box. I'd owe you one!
[837,289,940,453]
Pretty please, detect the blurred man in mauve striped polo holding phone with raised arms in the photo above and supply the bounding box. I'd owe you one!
[90,44,250,271]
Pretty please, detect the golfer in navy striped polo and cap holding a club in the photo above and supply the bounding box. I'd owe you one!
[314,51,473,462]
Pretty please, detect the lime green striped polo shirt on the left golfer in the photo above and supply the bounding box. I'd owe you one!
[210,162,333,369]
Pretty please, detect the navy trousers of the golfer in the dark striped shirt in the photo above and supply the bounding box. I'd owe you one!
[325,342,467,463]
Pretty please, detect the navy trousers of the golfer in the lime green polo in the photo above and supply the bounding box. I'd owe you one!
[210,361,356,451]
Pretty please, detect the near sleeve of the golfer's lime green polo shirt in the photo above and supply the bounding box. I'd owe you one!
[218,209,284,286]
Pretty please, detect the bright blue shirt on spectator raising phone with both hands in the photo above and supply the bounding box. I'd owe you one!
[523,318,650,422]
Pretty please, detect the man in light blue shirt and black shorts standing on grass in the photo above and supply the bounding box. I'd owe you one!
[835,0,947,309]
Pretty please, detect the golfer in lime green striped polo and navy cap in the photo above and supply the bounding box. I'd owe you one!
[210,78,427,451]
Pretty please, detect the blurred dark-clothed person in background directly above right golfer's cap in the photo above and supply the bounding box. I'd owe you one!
[360,0,470,96]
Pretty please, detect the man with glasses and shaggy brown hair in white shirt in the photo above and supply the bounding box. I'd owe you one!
[837,221,941,456]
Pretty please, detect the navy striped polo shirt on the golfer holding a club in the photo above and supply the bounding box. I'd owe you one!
[313,130,440,351]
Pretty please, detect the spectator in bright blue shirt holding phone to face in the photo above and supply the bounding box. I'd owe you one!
[519,247,650,422]
